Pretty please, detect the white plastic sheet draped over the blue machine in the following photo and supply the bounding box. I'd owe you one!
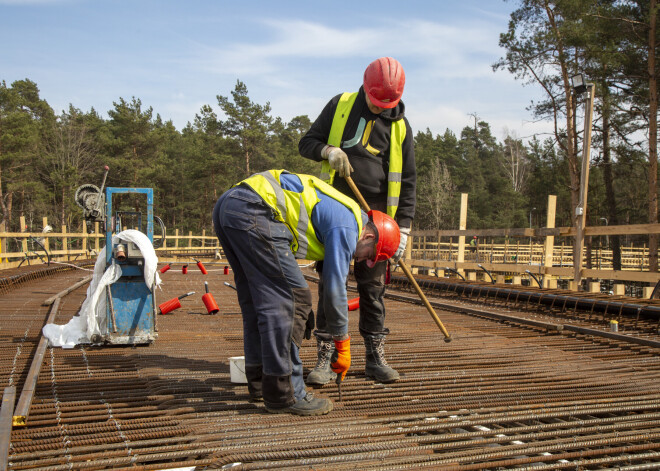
[42,229,160,348]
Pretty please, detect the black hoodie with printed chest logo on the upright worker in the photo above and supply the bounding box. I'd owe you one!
[298,87,417,227]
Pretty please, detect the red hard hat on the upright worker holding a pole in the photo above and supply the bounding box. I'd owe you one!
[364,57,406,108]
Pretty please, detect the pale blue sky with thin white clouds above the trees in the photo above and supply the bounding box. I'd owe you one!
[0,0,550,140]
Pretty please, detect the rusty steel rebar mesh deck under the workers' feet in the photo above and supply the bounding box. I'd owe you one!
[0,266,660,471]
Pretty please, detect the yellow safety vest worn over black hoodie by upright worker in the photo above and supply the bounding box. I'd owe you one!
[321,92,406,218]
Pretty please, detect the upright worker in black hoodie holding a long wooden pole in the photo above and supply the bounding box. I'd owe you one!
[298,57,417,385]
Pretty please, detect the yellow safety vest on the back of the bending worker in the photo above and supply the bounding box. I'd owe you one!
[238,170,362,260]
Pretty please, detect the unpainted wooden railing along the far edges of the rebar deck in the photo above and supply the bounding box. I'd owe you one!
[0,213,660,296]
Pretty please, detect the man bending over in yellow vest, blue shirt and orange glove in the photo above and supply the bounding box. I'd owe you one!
[213,170,400,415]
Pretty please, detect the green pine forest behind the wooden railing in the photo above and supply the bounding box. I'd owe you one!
[0,0,658,267]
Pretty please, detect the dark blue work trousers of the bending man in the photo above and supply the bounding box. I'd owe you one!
[213,186,313,405]
